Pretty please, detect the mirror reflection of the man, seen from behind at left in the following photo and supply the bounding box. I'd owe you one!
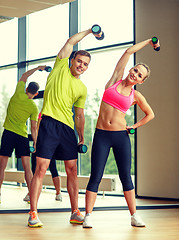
[0,66,45,201]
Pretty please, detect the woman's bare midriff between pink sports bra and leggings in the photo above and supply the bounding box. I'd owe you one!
[96,102,126,131]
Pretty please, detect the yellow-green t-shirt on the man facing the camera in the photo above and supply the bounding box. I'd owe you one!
[42,56,87,129]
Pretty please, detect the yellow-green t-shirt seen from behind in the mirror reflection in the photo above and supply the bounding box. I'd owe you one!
[3,81,38,137]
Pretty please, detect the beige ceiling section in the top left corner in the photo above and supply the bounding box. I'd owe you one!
[0,0,76,23]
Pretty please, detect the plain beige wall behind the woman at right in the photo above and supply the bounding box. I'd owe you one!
[136,0,179,198]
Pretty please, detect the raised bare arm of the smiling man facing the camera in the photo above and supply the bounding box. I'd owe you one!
[58,29,92,59]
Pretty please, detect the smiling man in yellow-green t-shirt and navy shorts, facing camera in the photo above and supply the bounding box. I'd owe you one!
[28,29,100,227]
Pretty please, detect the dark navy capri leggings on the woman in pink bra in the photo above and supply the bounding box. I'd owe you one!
[87,129,134,192]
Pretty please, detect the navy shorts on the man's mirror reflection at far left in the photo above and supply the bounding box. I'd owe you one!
[0,129,30,158]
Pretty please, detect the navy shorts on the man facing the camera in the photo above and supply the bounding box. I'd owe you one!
[36,116,78,160]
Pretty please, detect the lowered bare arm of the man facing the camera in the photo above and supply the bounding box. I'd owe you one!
[74,107,85,144]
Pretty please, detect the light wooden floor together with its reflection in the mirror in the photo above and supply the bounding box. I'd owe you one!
[0,185,179,240]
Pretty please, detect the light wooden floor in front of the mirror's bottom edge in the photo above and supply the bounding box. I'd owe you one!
[0,209,179,240]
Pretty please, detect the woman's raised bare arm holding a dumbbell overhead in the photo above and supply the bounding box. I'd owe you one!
[105,39,154,89]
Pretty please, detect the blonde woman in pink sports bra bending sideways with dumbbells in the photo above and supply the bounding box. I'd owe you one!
[83,39,158,228]
